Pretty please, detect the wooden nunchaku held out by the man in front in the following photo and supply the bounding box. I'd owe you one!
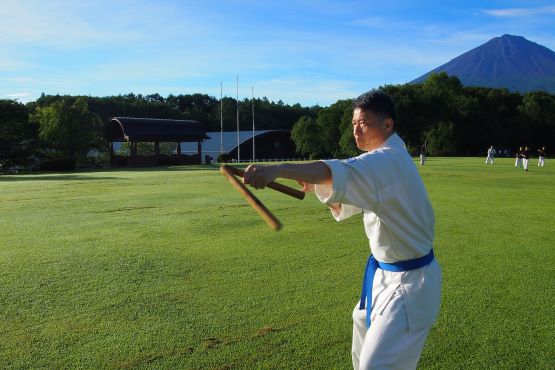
[220,164,305,231]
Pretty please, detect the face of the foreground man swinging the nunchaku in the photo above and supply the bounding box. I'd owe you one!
[353,108,393,151]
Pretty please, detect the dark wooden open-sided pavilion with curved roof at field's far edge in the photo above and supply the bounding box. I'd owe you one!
[105,117,209,166]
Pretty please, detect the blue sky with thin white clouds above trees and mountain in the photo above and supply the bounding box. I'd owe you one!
[0,0,555,106]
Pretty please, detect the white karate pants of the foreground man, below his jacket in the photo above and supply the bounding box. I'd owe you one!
[352,292,430,370]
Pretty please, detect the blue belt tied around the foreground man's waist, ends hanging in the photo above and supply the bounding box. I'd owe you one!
[359,249,434,328]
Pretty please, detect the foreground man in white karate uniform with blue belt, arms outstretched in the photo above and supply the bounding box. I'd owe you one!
[244,90,441,369]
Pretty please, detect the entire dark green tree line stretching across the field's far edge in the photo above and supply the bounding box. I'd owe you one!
[0,73,555,169]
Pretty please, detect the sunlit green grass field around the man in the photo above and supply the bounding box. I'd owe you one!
[0,158,555,369]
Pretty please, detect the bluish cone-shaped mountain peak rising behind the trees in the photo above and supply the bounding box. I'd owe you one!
[411,34,555,93]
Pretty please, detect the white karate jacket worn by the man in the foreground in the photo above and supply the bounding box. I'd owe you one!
[315,134,441,330]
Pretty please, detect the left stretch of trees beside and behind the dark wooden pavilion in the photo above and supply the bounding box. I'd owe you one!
[0,94,321,169]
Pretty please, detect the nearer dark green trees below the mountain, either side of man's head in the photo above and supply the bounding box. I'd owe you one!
[291,72,555,158]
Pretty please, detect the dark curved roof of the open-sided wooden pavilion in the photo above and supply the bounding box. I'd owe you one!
[105,117,208,142]
